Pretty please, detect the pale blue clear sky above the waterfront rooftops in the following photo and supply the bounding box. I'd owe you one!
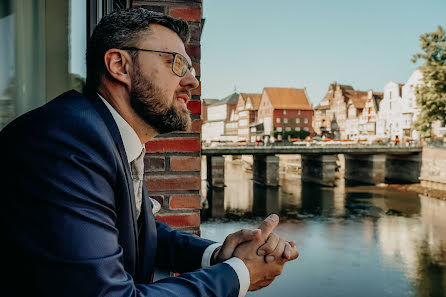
[201,0,446,106]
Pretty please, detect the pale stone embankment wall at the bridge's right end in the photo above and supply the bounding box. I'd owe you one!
[420,147,446,191]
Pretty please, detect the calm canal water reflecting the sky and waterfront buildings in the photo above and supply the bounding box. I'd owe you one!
[201,157,446,297]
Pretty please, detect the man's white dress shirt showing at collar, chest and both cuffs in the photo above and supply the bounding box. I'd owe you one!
[98,94,250,297]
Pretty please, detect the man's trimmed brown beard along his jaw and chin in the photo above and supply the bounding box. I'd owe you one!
[130,65,191,134]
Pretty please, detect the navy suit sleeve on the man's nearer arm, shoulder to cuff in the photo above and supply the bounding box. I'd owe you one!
[0,106,239,297]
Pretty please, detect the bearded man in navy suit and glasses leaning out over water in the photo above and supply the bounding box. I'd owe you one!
[0,9,298,297]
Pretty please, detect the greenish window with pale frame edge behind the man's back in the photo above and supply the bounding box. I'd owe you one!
[0,0,87,129]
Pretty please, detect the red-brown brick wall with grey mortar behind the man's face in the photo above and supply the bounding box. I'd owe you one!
[133,0,202,234]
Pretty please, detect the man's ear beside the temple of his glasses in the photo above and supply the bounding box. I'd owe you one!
[104,48,132,88]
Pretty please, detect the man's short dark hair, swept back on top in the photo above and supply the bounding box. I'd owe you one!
[84,8,190,94]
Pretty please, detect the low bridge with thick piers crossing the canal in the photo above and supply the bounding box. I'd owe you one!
[201,143,423,187]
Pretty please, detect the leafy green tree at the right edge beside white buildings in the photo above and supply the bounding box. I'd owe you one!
[412,26,446,137]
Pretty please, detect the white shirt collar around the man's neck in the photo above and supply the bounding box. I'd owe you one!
[98,94,145,163]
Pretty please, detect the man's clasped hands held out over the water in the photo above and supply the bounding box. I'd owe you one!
[213,214,299,291]
